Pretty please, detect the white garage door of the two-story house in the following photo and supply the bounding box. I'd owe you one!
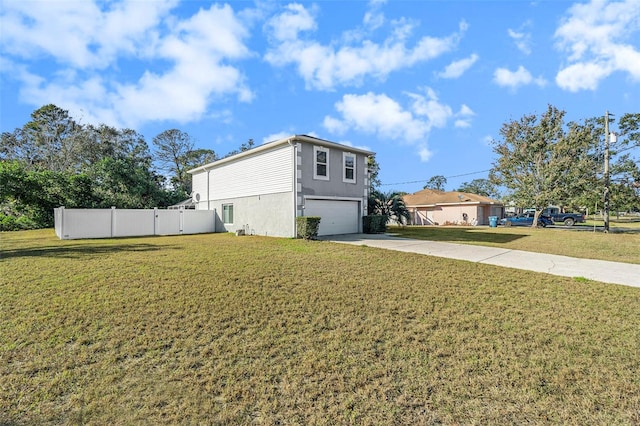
[304,200,360,235]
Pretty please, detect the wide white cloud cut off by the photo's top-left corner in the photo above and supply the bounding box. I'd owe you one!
[1,0,177,69]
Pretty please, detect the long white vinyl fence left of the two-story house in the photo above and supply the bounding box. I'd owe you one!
[54,207,215,240]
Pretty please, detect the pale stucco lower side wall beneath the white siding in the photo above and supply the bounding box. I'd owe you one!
[211,192,295,237]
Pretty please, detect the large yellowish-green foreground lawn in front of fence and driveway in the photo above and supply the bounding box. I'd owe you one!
[0,230,640,425]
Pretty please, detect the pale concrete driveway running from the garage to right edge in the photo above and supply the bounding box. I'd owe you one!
[321,234,640,287]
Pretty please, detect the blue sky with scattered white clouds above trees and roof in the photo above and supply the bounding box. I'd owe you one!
[0,0,640,193]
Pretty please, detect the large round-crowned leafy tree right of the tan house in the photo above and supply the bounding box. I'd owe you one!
[490,105,597,227]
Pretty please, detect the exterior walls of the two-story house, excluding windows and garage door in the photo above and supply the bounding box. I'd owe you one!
[192,140,369,237]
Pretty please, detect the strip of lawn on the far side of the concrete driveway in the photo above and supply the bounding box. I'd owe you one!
[389,226,640,263]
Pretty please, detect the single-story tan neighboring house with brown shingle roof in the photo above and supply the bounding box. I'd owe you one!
[402,189,504,225]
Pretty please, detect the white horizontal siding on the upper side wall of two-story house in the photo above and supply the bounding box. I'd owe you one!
[210,145,294,201]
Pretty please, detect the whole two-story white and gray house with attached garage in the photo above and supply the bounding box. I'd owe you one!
[189,135,374,237]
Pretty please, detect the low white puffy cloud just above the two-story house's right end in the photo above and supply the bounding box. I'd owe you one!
[324,88,458,161]
